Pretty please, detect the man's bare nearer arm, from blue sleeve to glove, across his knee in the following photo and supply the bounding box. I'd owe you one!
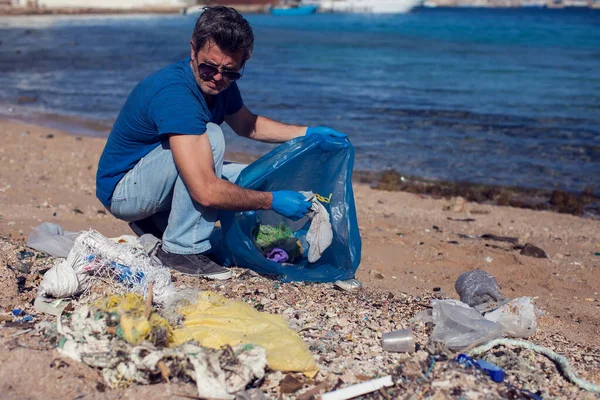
[169,134,273,211]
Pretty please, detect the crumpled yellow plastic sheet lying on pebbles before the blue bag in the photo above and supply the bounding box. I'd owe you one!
[173,292,319,378]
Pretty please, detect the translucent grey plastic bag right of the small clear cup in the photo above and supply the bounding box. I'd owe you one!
[431,300,502,351]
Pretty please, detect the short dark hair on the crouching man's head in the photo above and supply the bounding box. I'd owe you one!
[192,6,254,62]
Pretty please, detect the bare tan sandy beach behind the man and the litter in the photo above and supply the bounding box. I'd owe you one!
[0,119,600,398]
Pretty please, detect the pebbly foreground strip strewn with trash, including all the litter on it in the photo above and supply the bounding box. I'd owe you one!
[0,223,600,400]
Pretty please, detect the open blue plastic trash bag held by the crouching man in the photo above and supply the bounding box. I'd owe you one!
[221,136,361,282]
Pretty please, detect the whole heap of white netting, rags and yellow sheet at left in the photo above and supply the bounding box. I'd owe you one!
[18,225,318,399]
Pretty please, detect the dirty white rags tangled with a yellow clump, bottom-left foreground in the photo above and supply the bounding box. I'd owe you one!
[57,293,267,399]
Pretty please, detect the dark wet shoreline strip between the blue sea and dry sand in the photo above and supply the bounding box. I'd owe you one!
[0,105,600,220]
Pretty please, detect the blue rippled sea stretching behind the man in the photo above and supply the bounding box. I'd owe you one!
[0,8,600,194]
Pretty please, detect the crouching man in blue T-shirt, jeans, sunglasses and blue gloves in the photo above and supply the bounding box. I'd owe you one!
[96,7,345,279]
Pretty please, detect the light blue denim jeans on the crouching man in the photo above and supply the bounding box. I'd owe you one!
[110,123,245,254]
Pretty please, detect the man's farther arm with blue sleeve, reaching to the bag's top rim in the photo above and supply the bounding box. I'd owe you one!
[225,105,306,143]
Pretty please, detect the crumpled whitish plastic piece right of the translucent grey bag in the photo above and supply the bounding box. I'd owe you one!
[485,297,537,338]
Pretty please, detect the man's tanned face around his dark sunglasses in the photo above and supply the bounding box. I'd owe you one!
[191,41,243,96]
